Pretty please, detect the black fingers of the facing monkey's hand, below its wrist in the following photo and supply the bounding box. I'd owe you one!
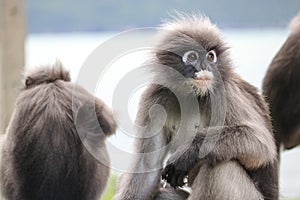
[162,163,188,188]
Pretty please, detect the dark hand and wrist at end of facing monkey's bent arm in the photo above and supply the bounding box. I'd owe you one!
[162,142,200,188]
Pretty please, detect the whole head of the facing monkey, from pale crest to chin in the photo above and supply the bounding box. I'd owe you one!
[156,17,231,96]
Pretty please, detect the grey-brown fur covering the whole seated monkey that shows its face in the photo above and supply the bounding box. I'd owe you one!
[115,15,278,200]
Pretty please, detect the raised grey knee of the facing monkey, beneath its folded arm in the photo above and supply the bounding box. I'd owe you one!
[188,161,263,200]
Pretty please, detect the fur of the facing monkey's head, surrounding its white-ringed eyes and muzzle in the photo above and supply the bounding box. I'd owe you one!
[152,12,232,96]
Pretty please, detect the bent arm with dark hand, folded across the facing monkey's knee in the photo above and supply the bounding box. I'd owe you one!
[163,125,276,187]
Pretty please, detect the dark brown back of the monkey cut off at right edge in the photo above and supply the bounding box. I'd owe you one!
[263,14,300,150]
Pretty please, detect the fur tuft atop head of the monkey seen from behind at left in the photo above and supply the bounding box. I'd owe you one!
[25,61,71,87]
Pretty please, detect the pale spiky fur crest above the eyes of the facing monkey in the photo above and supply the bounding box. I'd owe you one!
[156,12,228,53]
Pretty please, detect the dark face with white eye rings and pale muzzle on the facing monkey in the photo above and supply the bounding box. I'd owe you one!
[158,42,222,96]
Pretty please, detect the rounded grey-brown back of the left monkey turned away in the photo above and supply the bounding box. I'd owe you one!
[1,77,109,200]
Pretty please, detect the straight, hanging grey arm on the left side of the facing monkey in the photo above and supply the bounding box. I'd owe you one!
[114,85,180,200]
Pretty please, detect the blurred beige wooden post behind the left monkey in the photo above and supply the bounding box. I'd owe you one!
[0,0,26,133]
